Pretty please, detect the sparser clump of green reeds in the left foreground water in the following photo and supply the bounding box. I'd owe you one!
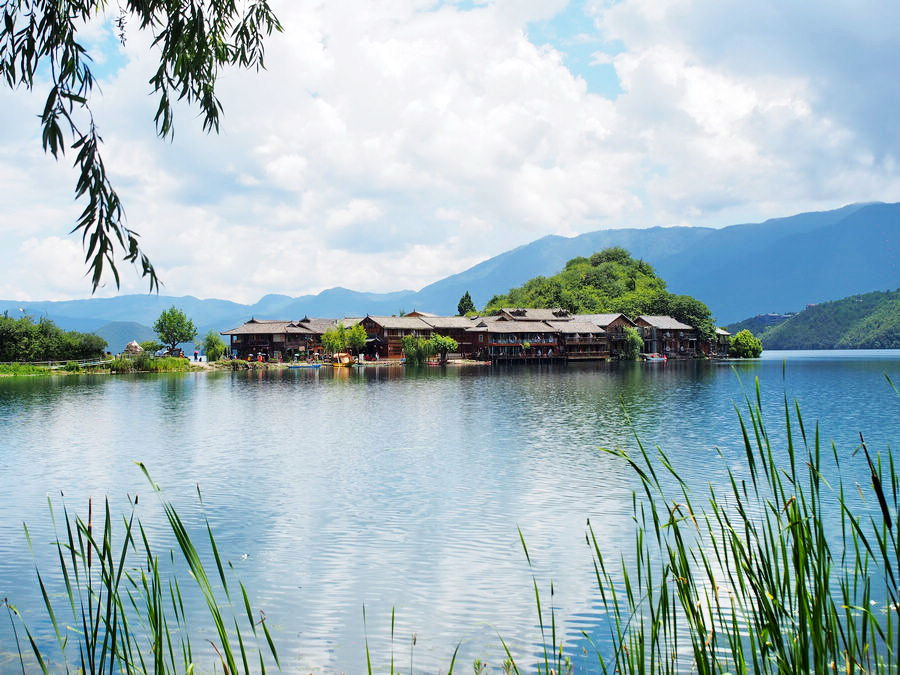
[4,465,280,673]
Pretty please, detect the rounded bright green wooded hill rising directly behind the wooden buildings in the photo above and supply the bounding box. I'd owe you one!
[484,246,715,338]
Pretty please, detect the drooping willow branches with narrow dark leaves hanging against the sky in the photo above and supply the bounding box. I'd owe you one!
[0,0,281,291]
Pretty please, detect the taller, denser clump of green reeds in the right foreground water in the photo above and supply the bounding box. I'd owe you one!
[572,381,900,673]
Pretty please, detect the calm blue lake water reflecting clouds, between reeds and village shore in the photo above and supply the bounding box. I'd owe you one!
[0,351,900,673]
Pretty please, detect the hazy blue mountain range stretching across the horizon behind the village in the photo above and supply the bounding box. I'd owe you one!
[0,203,900,335]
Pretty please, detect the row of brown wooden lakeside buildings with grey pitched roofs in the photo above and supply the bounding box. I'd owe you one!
[221,308,731,363]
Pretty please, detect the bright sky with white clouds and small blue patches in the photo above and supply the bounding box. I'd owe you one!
[0,0,900,303]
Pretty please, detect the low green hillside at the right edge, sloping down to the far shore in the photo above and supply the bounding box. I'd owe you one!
[759,290,900,349]
